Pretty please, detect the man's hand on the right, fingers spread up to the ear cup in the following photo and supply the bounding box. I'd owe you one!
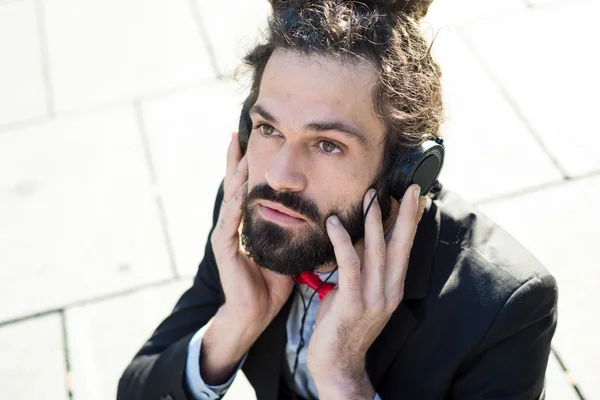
[307,185,429,399]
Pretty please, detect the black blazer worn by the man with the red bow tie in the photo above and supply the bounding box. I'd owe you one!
[117,186,557,400]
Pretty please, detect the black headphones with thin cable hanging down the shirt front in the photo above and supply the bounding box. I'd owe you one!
[238,96,446,400]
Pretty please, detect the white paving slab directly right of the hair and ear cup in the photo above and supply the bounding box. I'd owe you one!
[433,30,562,201]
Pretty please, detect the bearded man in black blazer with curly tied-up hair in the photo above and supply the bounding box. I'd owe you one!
[118,0,557,400]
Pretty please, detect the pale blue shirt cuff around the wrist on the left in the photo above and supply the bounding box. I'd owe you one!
[185,325,248,400]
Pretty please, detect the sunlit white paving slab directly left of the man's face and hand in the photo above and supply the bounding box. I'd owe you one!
[142,82,244,275]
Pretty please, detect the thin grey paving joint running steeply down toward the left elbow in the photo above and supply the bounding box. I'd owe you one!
[133,100,179,278]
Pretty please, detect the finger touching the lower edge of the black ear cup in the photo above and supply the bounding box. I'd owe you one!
[385,185,421,296]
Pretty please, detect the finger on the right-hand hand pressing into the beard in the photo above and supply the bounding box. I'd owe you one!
[327,216,361,300]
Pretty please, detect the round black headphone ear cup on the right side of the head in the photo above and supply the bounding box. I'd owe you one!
[388,138,446,202]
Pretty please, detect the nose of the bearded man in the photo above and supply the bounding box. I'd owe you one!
[265,144,306,192]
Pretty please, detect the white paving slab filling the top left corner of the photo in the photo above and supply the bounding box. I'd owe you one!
[0,0,48,126]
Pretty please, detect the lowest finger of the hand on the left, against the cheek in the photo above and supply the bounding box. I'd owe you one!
[212,182,248,251]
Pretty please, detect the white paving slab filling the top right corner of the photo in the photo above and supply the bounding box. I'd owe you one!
[466,1,600,175]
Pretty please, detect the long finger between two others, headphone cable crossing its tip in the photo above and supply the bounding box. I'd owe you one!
[362,189,386,301]
